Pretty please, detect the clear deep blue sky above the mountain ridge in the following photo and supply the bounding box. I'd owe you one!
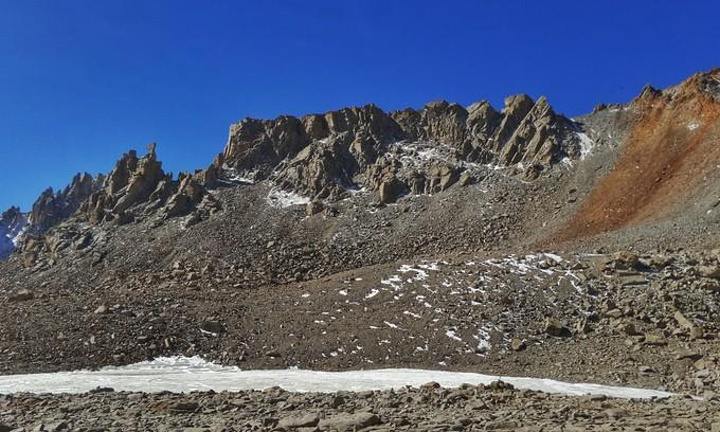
[0,0,720,209]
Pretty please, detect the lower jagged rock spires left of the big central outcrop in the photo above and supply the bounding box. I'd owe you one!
[22,143,219,266]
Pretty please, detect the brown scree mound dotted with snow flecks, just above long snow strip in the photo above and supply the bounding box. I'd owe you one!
[0,245,720,395]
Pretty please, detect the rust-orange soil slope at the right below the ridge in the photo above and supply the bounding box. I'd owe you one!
[553,75,720,241]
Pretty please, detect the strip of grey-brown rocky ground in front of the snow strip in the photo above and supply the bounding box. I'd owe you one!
[0,382,720,432]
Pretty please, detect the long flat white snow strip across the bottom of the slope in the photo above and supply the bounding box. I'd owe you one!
[0,357,672,399]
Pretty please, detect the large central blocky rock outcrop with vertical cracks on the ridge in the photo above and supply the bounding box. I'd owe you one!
[222,95,582,201]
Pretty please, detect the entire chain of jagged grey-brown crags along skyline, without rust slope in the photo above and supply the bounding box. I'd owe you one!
[0,91,587,258]
